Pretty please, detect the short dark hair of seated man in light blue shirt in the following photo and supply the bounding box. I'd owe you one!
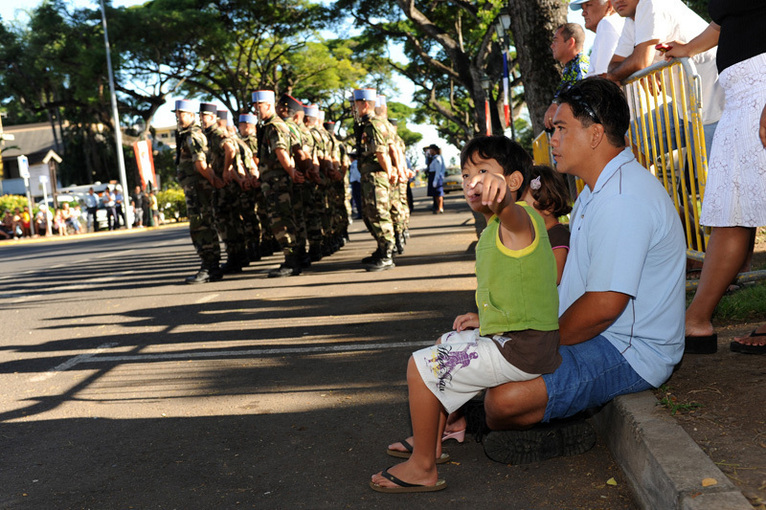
[555,76,630,147]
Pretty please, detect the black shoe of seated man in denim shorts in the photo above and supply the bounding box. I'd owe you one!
[482,418,596,465]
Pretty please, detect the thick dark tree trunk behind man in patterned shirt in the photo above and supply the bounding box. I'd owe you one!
[508,0,567,133]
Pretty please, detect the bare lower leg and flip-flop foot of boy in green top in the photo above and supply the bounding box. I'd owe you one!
[372,357,447,487]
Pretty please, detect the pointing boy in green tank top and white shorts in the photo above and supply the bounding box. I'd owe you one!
[370,136,561,493]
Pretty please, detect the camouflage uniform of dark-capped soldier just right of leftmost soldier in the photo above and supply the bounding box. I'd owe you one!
[205,124,246,268]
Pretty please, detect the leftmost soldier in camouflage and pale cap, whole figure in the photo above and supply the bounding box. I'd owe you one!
[175,100,223,284]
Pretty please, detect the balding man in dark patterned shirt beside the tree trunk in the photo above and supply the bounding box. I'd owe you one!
[543,23,589,129]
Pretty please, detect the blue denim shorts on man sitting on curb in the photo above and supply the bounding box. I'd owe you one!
[543,335,652,422]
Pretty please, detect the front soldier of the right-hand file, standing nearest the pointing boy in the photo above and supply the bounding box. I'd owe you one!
[354,89,394,271]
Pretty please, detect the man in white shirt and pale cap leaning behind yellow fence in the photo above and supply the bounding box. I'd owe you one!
[569,0,625,77]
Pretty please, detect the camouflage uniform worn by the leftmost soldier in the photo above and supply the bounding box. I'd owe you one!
[176,125,221,271]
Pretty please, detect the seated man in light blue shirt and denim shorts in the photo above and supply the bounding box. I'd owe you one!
[484,78,686,462]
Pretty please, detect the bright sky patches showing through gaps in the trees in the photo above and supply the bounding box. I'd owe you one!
[0,0,593,165]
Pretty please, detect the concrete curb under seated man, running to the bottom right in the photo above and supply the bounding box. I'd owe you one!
[593,391,753,510]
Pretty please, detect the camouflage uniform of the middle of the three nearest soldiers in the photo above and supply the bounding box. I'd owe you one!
[258,114,298,261]
